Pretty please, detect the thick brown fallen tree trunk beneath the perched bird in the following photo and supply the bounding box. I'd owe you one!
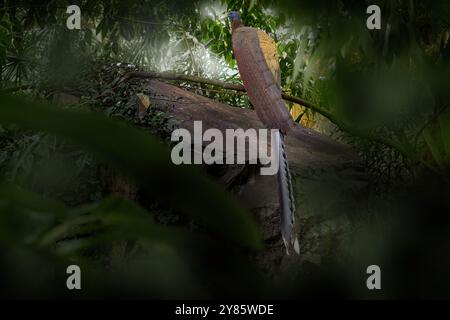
[144,79,366,275]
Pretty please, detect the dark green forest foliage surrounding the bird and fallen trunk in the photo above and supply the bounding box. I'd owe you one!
[0,0,450,298]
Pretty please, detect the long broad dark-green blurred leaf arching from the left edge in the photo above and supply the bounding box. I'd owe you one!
[0,95,261,249]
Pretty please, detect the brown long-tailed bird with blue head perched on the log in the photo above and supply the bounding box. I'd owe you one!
[228,11,300,254]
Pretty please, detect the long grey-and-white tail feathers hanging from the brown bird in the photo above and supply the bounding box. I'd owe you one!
[276,131,300,255]
